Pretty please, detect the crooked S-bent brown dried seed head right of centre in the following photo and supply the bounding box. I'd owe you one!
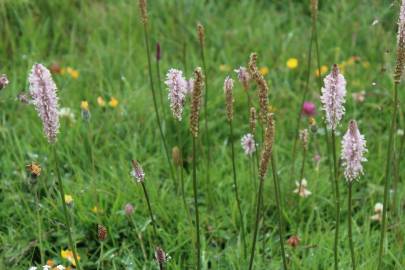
[249,53,269,125]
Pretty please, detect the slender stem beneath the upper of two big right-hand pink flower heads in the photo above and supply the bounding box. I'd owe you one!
[332,130,340,270]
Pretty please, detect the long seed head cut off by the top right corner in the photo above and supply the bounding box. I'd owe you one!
[394,0,405,84]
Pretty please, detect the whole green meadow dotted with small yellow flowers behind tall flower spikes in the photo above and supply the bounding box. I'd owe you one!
[0,0,405,270]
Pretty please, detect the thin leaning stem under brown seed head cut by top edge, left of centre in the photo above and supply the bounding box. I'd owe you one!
[143,23,175,184]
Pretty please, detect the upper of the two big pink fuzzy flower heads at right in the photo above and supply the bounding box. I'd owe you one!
[321,64,346,130]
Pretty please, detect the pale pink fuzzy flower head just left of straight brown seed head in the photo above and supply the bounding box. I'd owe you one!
[165,68,187,121]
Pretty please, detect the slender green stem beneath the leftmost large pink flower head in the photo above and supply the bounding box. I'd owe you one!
[52,144,81,270]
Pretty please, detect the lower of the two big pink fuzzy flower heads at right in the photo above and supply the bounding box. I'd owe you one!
[341,120,367,182]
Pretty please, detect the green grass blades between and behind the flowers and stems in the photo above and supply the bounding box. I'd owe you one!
[0,0,405,269]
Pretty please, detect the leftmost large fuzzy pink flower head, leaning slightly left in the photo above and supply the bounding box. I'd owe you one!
[28,64,59,143]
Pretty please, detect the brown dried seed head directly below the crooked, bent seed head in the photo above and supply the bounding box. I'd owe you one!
[259,113,275,180]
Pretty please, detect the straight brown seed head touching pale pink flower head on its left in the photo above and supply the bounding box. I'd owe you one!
[190,67,204,138]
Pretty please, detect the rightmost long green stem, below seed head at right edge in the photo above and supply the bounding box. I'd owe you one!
[377,83,398,269]
